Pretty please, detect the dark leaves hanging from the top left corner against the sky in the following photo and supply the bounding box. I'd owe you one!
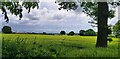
[0,1,39,22]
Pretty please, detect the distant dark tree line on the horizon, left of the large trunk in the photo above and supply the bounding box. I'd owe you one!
[2,26,96,36]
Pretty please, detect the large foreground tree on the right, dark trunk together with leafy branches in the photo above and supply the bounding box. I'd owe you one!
[58,0,120,47]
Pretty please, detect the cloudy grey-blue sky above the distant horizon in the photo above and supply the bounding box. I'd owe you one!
[0,0,118,33]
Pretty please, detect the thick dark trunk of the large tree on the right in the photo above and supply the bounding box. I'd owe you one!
[96,2,108,47]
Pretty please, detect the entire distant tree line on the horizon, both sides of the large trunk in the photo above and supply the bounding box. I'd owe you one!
[2,23,120,37]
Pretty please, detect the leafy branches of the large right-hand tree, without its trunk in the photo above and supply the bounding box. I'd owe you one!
[58,1,120,27]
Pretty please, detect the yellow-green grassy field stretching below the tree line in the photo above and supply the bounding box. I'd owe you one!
[2,34,120,58]
